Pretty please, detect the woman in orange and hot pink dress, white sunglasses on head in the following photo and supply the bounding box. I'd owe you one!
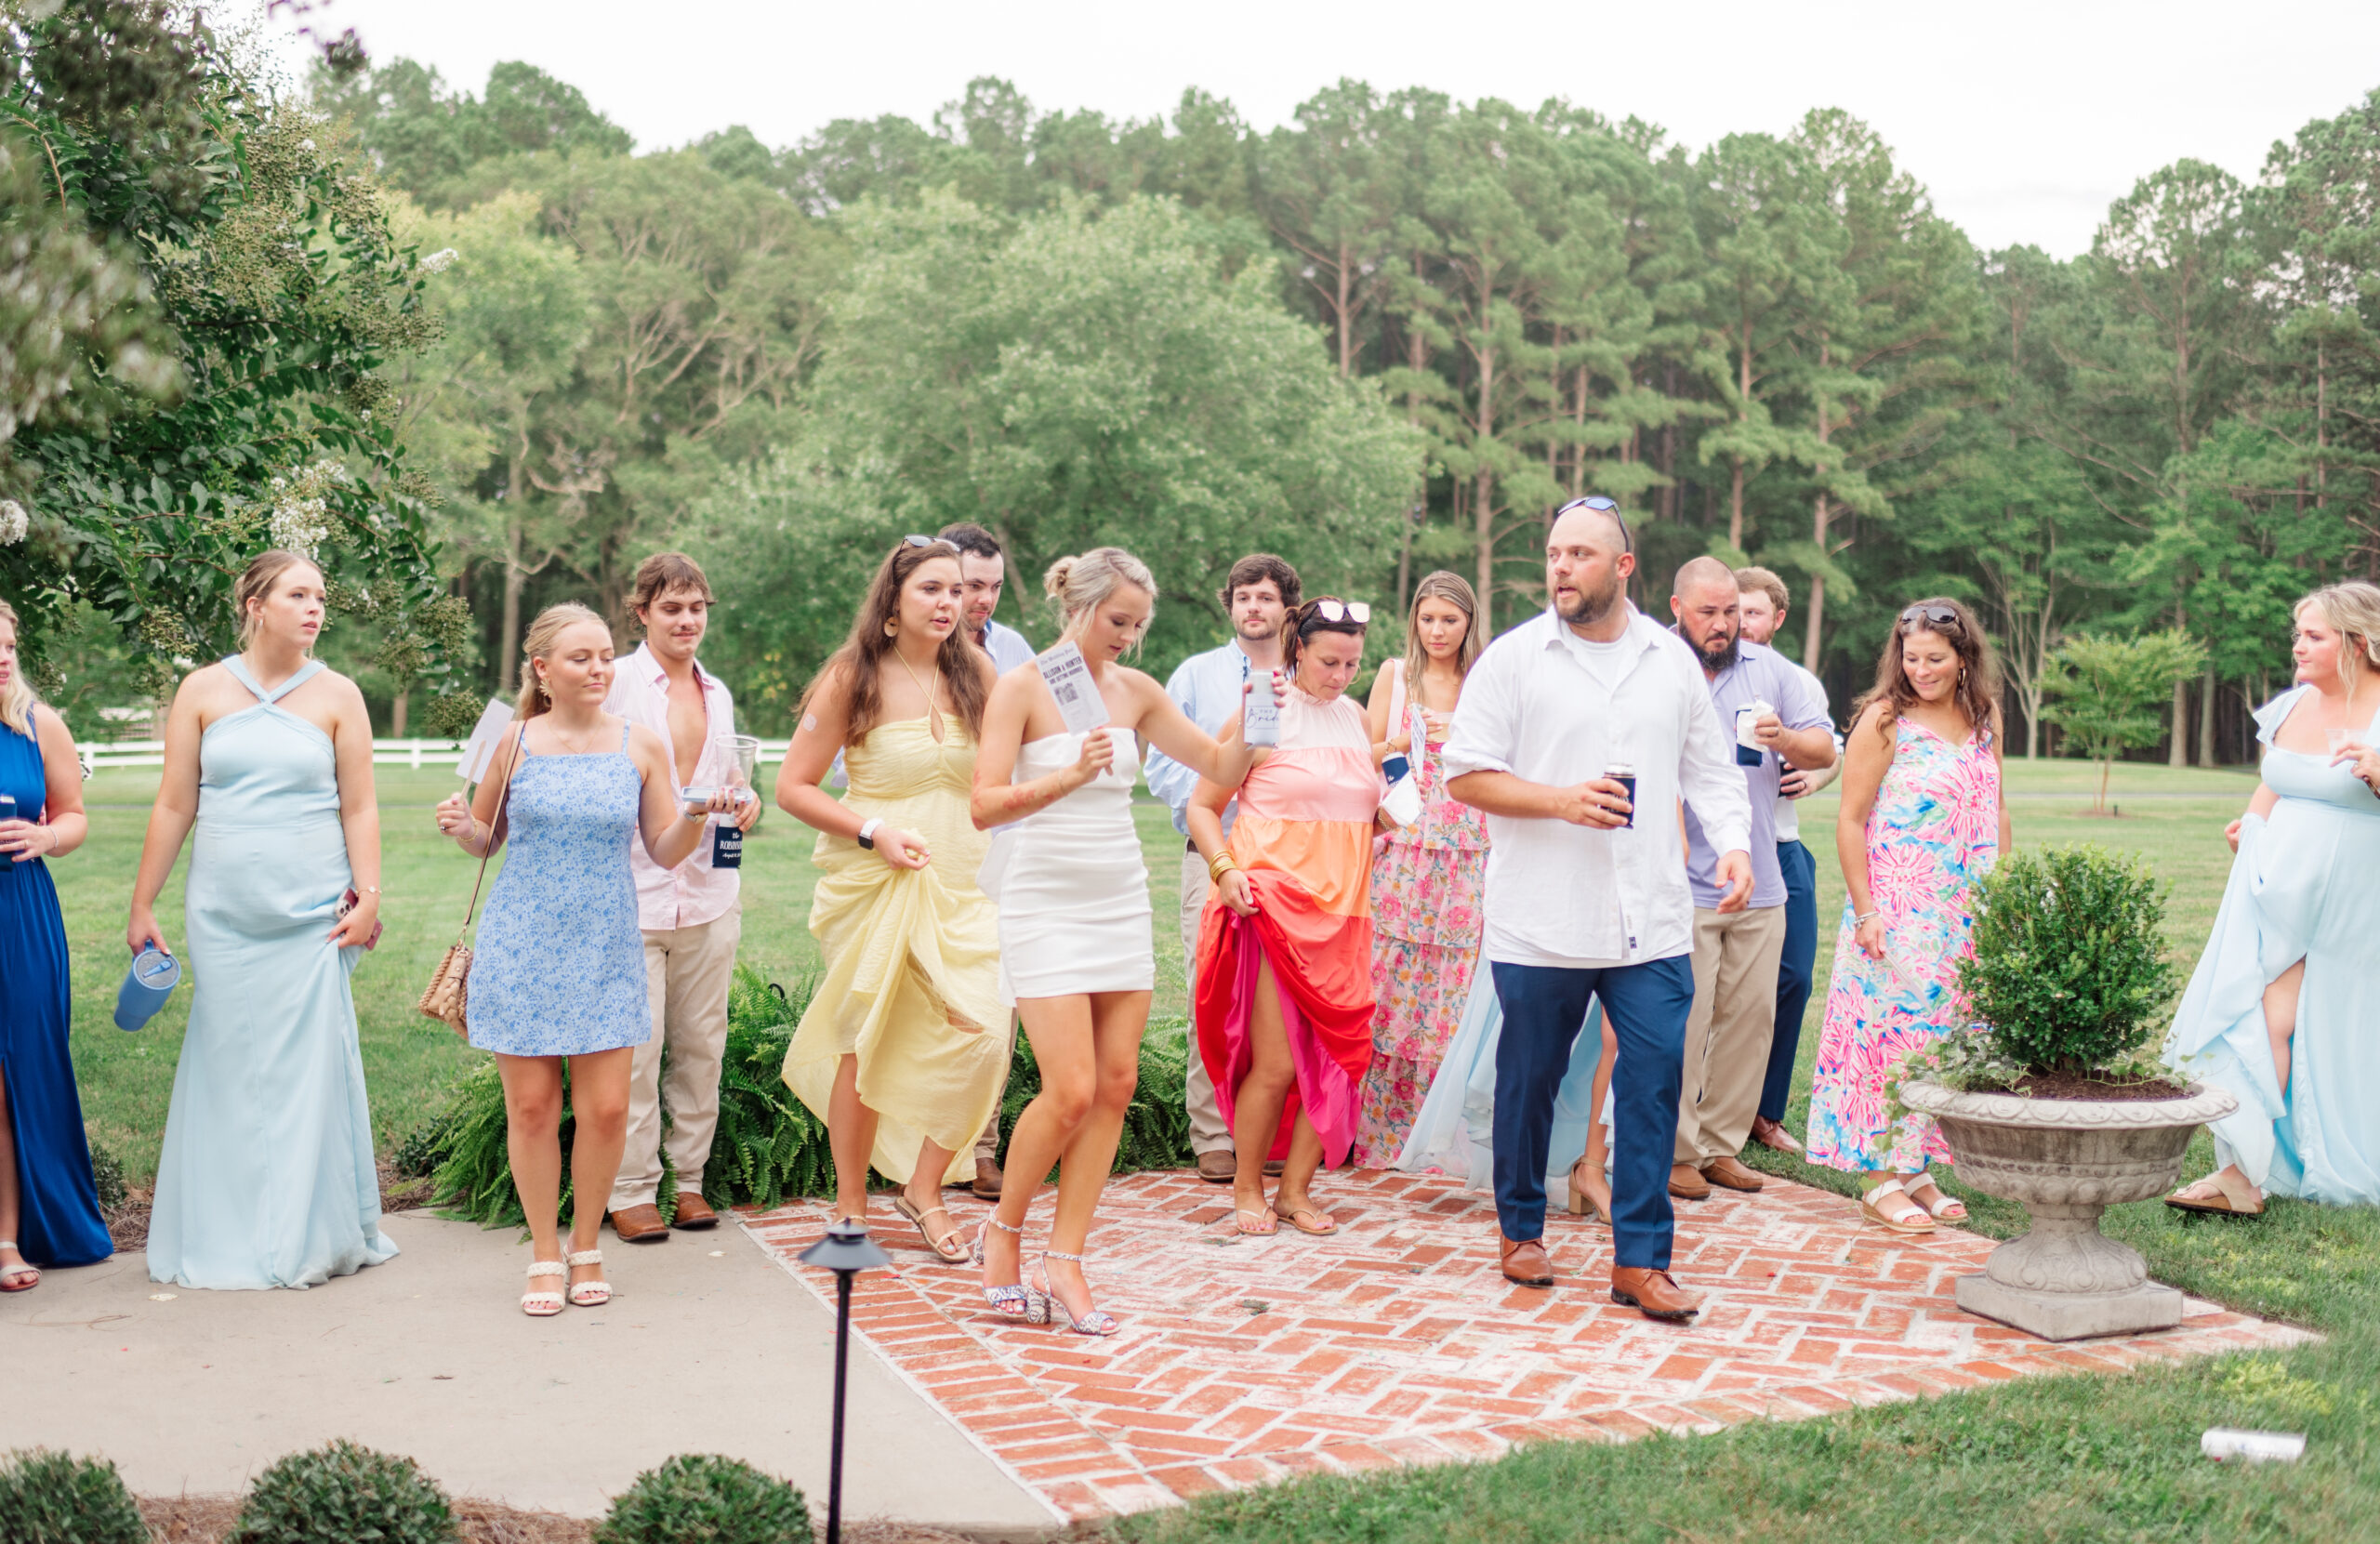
[1190,595,1387,1234]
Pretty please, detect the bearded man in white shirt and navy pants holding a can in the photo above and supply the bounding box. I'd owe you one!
[1445,497,1752,1320]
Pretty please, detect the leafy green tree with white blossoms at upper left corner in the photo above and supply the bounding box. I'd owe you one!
[0,0,469,718]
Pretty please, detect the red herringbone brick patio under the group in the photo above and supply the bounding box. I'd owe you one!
[743,1170,2308,1518]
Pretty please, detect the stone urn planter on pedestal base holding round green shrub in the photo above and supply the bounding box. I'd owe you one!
[1901,1082,2240,1339]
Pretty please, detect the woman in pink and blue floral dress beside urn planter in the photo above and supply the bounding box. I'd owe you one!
[1809,600,2011,1233]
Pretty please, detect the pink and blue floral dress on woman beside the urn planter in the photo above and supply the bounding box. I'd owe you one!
[1809,719,1999,1175]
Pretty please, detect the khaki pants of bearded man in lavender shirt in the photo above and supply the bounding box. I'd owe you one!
[1675,906,1785,1168]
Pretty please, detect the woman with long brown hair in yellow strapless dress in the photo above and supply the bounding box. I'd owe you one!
[776,535,1009,1263]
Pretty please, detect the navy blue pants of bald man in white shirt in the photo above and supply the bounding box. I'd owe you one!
[1490,954,1695,1271]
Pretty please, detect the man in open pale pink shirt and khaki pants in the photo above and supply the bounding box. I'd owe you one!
[604,552,760,1245]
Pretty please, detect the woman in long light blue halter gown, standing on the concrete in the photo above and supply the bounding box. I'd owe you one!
[126,552,398,1287]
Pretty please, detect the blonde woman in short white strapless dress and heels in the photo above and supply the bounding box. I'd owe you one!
[973,548,1278,1335]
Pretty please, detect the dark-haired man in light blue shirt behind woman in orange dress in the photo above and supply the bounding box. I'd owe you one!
[1147,552,1300,1185]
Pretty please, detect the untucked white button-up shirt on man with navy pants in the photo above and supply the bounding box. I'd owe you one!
[1445,607,1752,969]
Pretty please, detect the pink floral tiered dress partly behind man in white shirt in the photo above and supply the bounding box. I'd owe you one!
[1355,702,1488,1168]
